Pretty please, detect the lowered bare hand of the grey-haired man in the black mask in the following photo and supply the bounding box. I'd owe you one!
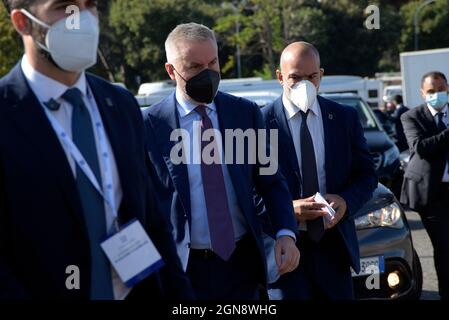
[274,236,300,275]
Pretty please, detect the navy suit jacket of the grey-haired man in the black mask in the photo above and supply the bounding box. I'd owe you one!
[144,92,296,282]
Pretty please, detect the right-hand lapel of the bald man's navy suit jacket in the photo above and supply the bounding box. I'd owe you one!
[318,96,338,192]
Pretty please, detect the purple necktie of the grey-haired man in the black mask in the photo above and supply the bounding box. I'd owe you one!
[195,106,235,261]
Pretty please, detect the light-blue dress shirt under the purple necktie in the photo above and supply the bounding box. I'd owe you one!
[176,89,296,249]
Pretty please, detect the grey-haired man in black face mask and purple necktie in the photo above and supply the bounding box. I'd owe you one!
[144,23,299,299]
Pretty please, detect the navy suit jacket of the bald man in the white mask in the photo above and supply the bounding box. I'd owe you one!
[262,96,377,271]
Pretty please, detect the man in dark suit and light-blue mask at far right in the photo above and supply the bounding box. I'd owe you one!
[401,72,449,300]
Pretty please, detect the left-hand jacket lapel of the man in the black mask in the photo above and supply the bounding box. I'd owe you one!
[153,93,191,220]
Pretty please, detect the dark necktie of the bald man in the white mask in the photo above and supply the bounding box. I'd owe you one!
[300,110,324,242]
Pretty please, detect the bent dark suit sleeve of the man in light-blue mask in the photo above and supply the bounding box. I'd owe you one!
[401,112,449,159]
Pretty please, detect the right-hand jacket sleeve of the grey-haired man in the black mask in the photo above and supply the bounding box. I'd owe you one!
[253,105,297,234]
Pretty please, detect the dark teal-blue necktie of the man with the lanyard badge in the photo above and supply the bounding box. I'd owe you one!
[62,88,114,300]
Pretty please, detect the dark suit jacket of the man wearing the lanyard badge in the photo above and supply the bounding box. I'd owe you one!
[0,64,193,299]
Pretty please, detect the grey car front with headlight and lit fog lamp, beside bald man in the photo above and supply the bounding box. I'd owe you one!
[353,184,423,300]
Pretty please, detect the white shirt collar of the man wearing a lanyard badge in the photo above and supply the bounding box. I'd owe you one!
[21,55,90,102]
